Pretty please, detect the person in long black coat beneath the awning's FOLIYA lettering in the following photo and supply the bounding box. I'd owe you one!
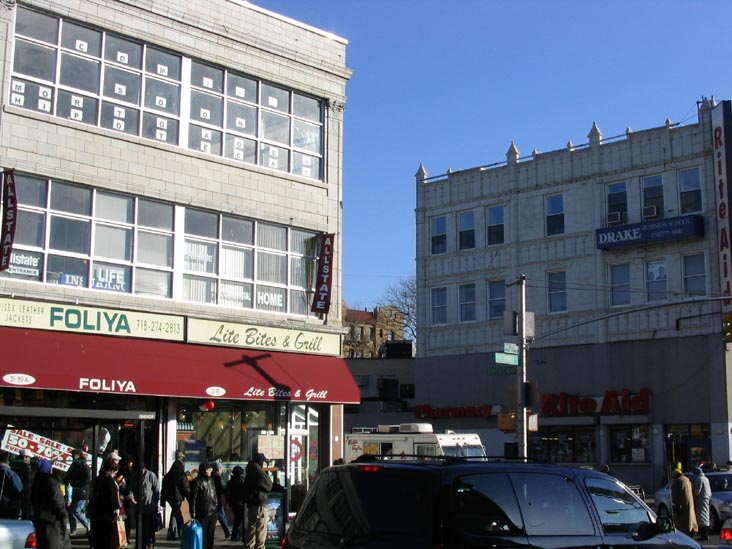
[89,452,121,549]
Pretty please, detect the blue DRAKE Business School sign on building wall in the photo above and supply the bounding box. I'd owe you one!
[595,215,704,250]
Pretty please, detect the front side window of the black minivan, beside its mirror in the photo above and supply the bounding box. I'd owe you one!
[585,478,650,535]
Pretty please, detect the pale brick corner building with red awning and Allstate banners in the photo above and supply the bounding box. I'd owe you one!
[0,0,359,524]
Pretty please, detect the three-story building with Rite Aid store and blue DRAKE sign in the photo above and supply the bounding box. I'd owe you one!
[416,99,732,491]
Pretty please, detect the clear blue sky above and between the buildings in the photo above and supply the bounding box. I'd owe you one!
[251,0,732,308]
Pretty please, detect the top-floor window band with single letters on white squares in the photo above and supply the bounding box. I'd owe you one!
[9,6,324,179]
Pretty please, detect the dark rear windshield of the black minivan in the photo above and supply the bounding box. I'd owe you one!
[295,465,437,546]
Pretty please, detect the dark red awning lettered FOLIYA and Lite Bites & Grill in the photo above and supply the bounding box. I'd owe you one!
[0,327,361,404]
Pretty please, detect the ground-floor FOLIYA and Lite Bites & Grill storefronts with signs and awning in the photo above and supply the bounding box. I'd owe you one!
[0,299,360,508]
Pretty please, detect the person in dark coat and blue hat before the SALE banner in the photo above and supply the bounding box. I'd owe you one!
[30,459,70,549]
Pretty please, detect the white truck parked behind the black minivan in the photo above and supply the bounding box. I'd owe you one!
[344,423,485,463]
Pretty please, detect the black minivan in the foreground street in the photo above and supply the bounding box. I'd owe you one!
[282,457,700,549]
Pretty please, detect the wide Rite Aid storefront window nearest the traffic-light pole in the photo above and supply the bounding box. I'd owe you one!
[529,427,597,463]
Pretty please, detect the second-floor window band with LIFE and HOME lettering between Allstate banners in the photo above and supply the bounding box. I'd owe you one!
[0,174,319,316]
